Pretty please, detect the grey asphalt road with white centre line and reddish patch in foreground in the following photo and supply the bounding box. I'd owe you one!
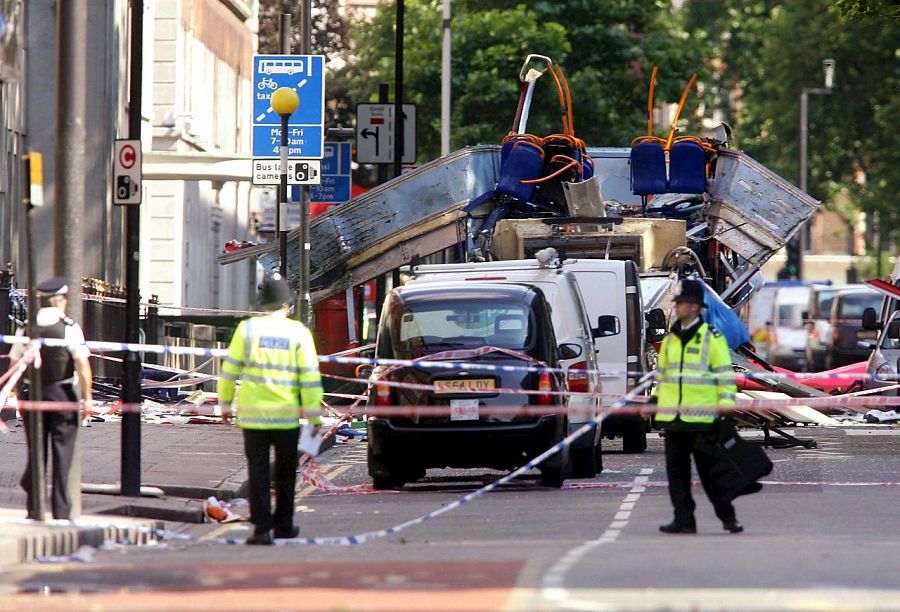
[0,427,900,610]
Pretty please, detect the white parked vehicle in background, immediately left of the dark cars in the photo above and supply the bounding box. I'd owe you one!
[766,285,810,371]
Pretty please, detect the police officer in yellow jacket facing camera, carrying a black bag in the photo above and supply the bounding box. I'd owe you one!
[655,279,744,533]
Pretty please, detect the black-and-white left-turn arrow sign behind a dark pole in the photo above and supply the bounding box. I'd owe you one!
[356,104,416,164]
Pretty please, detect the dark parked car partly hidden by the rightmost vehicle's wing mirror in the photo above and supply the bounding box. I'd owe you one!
[825,285,884,370]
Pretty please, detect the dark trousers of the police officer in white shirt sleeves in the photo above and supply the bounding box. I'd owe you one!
[20,381,81,520]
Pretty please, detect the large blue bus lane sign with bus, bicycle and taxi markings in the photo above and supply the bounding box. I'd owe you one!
[253,55,325,159]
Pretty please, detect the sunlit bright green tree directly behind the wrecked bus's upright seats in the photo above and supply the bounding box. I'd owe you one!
[347,0,704,160]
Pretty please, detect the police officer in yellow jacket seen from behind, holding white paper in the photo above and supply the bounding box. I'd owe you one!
[219,277,322,544]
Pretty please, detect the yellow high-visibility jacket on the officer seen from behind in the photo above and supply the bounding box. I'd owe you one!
[219,313,322,429]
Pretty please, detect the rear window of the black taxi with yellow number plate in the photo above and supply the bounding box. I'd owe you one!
[388,299,535,359]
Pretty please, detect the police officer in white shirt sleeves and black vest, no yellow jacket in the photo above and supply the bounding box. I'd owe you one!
[9,277,93,520]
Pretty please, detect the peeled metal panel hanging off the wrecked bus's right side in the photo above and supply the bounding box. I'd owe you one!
[707,151,819,265]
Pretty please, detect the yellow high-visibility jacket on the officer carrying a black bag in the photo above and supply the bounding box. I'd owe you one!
[655,322,737,423]
